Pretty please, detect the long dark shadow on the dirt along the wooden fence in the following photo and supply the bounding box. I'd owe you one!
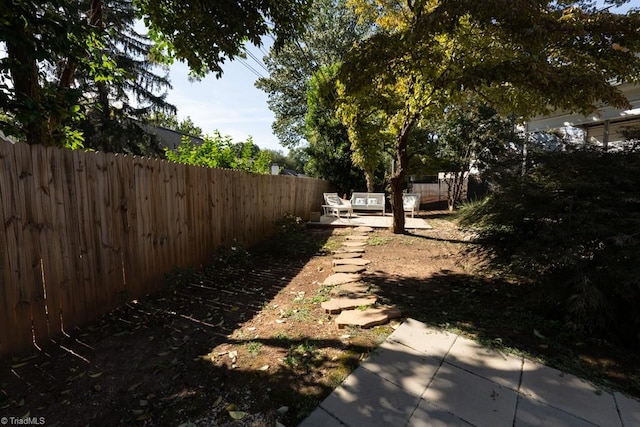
[0,230,370,426]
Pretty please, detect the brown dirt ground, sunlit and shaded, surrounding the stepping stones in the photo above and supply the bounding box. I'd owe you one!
[0,213,640,426]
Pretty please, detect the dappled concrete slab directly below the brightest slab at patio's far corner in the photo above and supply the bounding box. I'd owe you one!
[360,341,442,397]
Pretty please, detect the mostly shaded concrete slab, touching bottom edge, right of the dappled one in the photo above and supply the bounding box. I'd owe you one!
[422,364,518,427]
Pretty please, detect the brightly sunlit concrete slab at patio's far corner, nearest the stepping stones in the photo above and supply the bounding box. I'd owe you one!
[388,319,458,358]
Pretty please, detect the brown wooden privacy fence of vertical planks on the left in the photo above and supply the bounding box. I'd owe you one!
[0,141,329,356]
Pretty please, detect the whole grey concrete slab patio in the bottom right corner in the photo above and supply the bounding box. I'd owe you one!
[300,319,640,427]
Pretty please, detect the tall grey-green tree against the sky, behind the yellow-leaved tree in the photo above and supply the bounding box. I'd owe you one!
[256,0,368,148]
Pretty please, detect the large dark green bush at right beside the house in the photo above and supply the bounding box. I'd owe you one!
[460,151,640,345]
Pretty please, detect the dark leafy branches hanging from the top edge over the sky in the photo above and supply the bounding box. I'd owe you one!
[135,0,309,77]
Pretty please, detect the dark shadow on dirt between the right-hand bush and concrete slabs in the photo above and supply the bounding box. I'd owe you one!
[366,270,640,402]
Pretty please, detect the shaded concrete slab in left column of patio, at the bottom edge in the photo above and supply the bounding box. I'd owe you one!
[320,368,420,427]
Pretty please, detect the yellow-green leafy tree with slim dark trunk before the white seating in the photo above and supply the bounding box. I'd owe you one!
[340,0,640,233]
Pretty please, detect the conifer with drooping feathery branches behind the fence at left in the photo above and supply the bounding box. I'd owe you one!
[74,0,176,156]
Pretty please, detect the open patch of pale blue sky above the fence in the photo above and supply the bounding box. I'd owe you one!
[167,40,288,154]
